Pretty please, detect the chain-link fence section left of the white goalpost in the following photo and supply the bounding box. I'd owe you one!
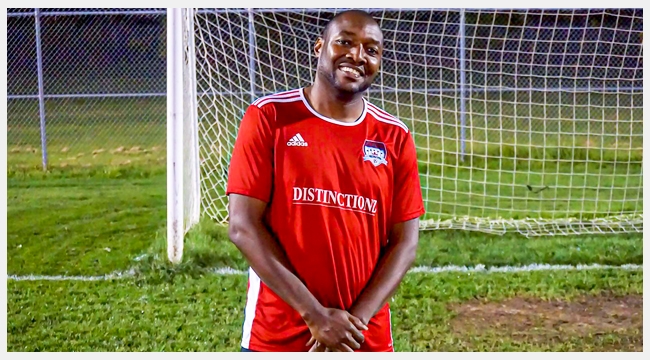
[7,8,166,167]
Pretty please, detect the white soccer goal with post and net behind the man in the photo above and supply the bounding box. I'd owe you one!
[167,9,643,257]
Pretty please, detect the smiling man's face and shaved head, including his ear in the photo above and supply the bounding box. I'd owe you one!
[314,14,383,93]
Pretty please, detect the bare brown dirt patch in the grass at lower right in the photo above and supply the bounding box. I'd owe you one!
[450,294,643,350]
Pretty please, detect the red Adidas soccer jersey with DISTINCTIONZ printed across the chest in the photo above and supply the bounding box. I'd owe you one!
[227,89,424,351]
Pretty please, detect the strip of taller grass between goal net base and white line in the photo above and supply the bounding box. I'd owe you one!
[141,218,643,272]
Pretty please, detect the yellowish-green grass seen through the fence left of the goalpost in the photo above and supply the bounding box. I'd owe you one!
[7,98,167,171]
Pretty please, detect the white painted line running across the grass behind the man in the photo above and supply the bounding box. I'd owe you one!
[7,264,643,281]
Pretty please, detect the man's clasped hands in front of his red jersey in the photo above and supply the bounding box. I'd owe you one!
[305,308,368,352]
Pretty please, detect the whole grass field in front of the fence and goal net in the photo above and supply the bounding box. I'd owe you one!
[7,168,643,351]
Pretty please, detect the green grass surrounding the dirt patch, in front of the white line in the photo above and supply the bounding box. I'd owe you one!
[392,271,643,351]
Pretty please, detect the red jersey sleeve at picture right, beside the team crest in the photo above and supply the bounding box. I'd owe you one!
[391,134,425,224]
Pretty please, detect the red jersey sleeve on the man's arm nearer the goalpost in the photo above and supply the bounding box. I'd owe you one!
[226,105,274,203]
